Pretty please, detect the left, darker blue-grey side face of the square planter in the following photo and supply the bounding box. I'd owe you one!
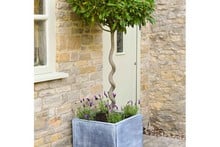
[73,119,116,147]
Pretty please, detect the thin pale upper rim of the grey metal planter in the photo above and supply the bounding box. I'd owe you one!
[73,114,142,126]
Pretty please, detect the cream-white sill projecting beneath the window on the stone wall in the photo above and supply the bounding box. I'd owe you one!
[34,72,69,83]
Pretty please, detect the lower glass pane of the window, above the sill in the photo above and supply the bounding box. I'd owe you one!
[34,20,47,66]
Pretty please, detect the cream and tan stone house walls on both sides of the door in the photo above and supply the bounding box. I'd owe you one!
[34,0,185,147]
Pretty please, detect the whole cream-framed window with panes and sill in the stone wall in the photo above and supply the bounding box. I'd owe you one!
[34,0,68,82]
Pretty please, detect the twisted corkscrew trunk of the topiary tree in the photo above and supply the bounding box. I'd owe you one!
[108,32,116,105]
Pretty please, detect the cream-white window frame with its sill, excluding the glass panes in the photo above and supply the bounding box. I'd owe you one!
[34,0,68,83]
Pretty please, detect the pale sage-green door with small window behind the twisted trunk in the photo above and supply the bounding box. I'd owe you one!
[103,27,138,107]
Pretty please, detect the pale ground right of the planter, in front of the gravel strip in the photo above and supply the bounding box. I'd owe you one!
[144,135,185,147]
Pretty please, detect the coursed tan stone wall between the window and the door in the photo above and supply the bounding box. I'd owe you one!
[34,0,102,147]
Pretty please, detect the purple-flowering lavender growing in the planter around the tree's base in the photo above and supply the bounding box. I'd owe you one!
[76,92,138,123]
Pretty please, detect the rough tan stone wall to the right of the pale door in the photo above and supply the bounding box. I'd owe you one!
[141,0,185,135]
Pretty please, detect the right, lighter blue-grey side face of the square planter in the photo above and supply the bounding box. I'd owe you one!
[116,114,143,147]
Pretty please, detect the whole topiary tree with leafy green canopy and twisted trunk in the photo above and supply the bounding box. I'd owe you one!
[67,0,155,105]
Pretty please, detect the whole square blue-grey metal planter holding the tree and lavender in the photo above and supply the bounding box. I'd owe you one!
[72,114,143,147]
